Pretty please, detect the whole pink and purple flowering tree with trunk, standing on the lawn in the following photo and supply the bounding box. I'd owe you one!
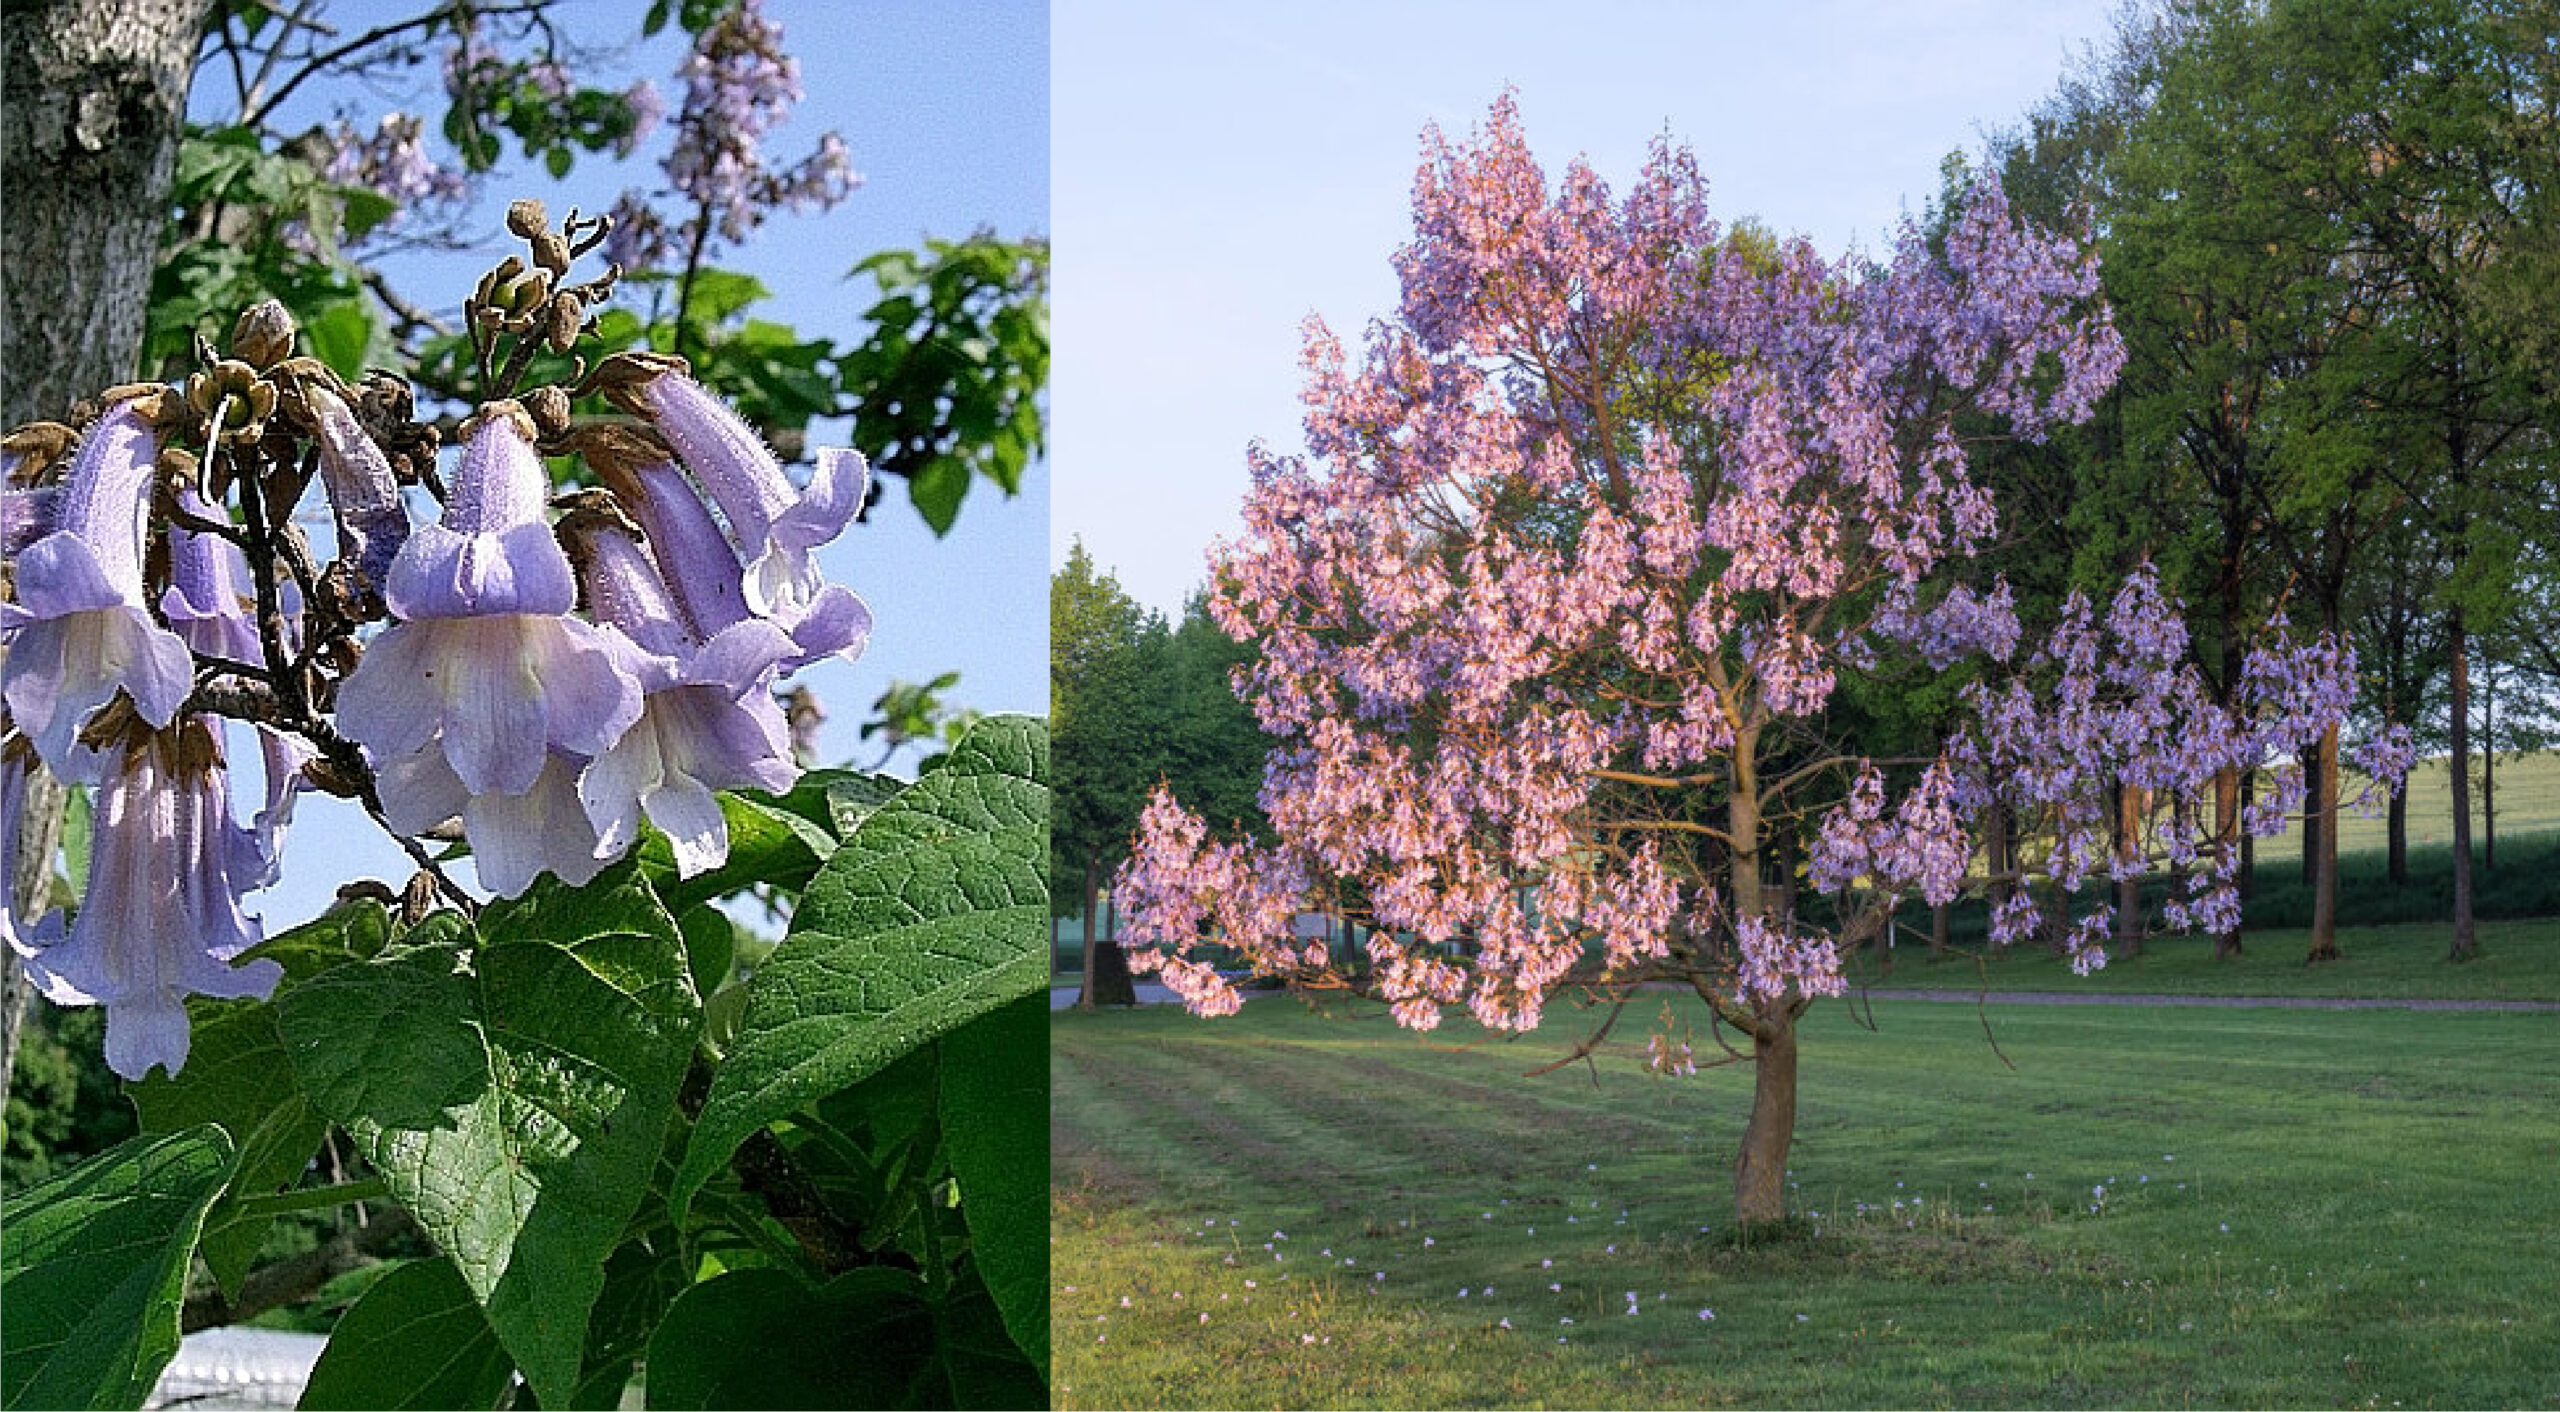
[1119,97,2396,1223]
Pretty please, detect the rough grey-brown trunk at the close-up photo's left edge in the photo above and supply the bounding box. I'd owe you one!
[0,0,212,1092]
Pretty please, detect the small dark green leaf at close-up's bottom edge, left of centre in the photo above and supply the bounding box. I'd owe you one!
[302,1259,515,1412]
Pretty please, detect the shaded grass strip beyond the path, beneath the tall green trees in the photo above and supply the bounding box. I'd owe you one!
[1851,918,2560,1000]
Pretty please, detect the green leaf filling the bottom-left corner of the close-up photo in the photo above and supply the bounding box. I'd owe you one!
[0,1123,230,1407]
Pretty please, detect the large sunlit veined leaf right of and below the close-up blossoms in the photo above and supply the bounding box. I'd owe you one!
[671,716,1050,1218]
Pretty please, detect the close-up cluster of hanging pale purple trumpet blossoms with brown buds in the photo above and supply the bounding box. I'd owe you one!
[0,276,870,1077]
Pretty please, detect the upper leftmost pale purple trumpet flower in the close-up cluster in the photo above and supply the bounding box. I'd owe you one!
[0,402,195,780]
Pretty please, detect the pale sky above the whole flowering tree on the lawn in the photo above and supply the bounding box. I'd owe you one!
[1050,0,2115,614]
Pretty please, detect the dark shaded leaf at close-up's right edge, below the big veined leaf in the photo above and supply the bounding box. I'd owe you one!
[942,992,1050,1371]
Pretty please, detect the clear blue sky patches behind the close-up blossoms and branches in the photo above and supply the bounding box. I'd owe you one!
[195,0,1050,931]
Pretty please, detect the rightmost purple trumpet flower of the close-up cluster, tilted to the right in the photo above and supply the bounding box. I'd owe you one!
[619,368,870,655]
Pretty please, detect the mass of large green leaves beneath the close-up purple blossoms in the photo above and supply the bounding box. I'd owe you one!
[0,719,1050,1407]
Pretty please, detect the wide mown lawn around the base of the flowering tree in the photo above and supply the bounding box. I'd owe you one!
[1052,982,2560,1407]
